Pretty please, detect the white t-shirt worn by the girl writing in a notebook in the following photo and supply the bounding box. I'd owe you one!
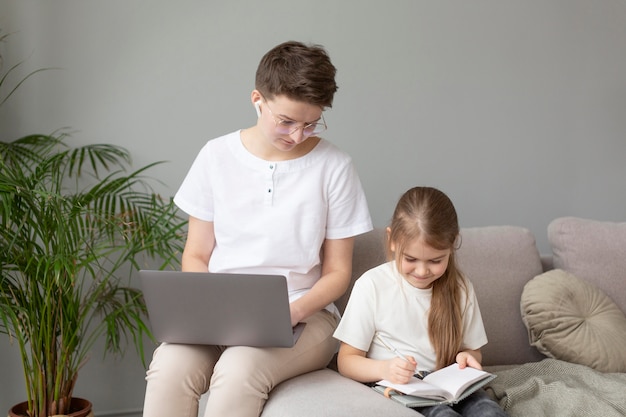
[334,261,487,370]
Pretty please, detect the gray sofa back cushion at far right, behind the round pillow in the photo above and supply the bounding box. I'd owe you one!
[548,217,626,313]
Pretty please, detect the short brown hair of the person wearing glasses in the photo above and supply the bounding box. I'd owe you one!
[255,41,337,108]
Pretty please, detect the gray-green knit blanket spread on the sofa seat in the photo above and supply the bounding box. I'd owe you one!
[487,359,626,417]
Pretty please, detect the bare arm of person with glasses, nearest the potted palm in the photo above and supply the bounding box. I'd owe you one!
[182,216,215,272]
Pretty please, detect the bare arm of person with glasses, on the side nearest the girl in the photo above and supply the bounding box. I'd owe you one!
[290,238,354,326]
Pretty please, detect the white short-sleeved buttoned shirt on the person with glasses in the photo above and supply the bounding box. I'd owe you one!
[174,131,372,308]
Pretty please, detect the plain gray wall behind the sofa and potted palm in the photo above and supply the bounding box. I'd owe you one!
[0,0,626,415]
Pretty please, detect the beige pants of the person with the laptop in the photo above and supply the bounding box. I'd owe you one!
[143,310,338,417]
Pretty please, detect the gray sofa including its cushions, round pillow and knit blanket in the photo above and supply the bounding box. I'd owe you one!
[200,217,626,417]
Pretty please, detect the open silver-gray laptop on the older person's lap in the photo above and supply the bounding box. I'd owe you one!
[139,270,304,347]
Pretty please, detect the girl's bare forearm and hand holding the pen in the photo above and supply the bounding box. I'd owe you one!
[337,342,417,384]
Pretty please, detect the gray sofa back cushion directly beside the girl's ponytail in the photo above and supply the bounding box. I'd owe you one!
[457,226,545,366]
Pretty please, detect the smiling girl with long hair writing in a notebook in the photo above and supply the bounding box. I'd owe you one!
[334,187,506,416]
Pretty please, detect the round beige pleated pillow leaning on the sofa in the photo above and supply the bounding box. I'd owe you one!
[520,269,626,372]
